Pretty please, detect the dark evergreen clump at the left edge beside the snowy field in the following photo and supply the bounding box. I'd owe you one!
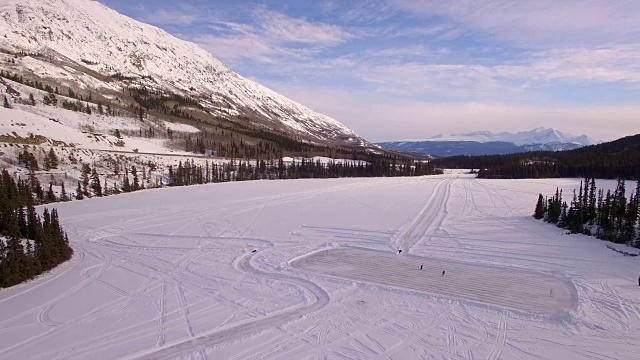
[0,170,73,287]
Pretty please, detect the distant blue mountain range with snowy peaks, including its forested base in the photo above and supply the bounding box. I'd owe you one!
[378,128,595,156]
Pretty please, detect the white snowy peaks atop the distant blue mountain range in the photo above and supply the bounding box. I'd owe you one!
[424,128,595,146]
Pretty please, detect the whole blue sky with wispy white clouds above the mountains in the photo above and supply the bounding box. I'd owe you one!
[101,0,640,141]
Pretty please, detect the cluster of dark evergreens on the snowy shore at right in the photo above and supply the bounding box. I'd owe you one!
[533,178,640,247]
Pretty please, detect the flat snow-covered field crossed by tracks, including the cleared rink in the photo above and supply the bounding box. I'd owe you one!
[0,174,640,359]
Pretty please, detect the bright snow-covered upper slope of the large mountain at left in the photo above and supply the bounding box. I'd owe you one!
[0,0,371,146]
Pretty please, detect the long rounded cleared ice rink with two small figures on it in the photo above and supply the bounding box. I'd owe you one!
[291,248,576,315]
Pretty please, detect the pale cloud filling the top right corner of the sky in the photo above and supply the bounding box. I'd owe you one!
[389,0,640,48]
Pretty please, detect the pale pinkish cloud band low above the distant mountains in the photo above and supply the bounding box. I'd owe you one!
[269,82,640,141]
